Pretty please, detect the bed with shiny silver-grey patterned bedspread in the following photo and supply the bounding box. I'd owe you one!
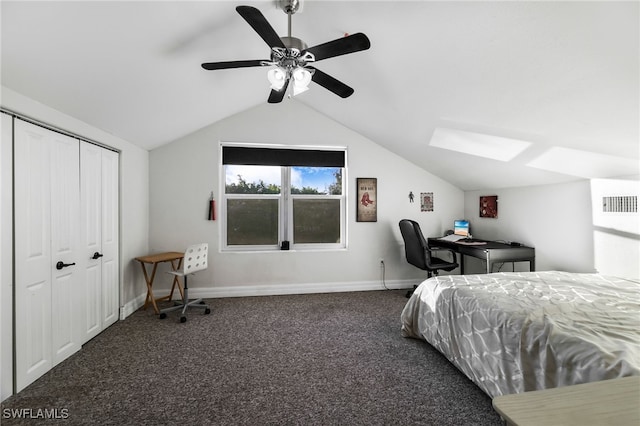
[401,271,640,398]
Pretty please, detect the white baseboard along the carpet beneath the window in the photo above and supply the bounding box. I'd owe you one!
[120,280,420,320]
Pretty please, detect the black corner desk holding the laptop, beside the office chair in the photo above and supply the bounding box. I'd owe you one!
[427,238,536,275]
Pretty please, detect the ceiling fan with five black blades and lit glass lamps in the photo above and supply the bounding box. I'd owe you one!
[202,0,371,103]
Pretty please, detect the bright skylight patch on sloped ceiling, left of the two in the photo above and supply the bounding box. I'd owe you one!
[429,127,531,161]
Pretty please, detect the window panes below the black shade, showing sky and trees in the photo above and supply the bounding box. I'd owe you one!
[223,159,345,249]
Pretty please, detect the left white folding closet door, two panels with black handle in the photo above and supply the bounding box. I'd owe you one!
[14,120,80,391]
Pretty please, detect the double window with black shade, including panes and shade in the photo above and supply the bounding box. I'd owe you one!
[221,145,346,250]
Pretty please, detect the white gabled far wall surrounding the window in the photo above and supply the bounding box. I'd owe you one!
[149,100,463,297]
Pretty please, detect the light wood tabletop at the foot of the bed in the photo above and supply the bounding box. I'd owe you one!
[493,376,640,426]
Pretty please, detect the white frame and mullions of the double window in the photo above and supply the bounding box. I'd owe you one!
[218,143,348,252]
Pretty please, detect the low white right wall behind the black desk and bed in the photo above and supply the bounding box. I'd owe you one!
[465,180,639,276]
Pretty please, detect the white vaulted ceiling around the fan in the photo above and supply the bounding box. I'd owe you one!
[0,0,640,190]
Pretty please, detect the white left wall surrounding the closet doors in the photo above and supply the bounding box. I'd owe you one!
[0,87,149,399]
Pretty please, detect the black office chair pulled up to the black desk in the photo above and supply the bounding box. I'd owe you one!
[399,219,458,297]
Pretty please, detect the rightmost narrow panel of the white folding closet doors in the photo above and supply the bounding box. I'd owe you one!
[102,149,120,328]
